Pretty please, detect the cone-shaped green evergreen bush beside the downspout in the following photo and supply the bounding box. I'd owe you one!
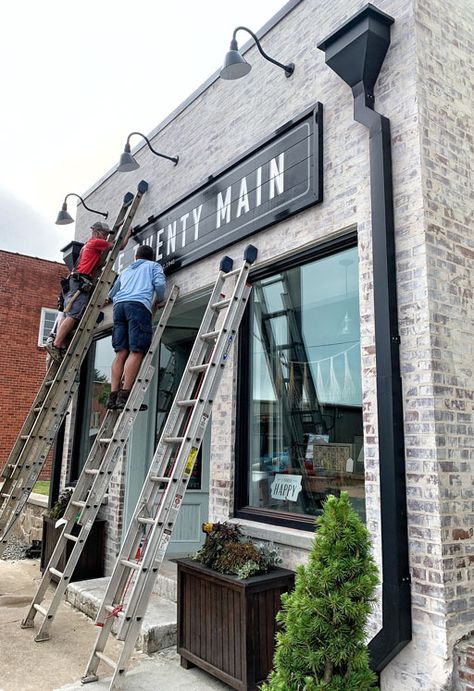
[261,492,378,691]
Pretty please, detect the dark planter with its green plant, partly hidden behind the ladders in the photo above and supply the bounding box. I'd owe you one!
[40,487,105,581]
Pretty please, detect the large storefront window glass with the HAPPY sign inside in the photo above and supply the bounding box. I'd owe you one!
[242,248,365,525]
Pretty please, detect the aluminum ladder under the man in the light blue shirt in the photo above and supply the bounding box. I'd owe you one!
[21,286,179,643]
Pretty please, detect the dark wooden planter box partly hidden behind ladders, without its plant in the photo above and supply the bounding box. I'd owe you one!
[40,516,105,581]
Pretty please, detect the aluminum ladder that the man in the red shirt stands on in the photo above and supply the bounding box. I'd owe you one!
[0,180,148,556]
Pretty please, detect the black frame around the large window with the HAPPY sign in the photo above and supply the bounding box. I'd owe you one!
[234,228,357,531]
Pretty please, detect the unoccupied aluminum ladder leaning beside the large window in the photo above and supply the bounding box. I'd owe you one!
[82,245,257,689]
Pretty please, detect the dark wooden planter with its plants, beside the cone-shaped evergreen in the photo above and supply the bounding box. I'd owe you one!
[177,523,294,691]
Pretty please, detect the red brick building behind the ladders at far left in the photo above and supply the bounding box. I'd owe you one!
[0,250,68,479]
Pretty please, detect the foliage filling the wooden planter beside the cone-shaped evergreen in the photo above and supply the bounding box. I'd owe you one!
[193,522,281,580]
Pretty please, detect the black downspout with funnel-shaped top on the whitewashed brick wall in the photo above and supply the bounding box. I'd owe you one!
[318,5,411,672]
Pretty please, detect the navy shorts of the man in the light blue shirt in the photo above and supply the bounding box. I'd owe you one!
[112,301,152,353]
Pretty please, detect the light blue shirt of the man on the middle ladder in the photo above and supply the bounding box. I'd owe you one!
[109,259,166,312]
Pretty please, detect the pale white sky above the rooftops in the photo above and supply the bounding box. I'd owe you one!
[0,0,286,261]
